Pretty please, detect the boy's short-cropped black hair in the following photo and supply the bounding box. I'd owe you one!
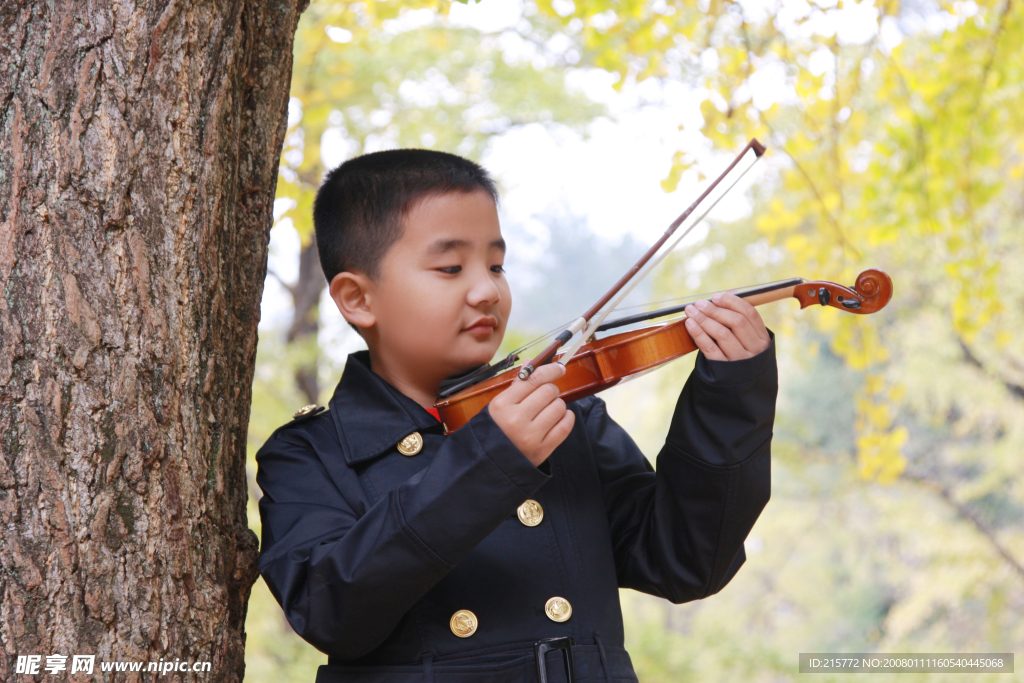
[313,150,499,288]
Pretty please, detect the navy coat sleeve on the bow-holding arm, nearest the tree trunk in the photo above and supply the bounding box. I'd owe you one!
[256,403,549,659]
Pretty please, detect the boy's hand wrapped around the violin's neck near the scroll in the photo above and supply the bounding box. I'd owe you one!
[686,292,771,360]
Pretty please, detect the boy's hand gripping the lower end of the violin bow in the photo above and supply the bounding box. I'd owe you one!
[489,362,575,467]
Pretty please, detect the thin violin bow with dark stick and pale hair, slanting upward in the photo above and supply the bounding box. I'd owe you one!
[518,138,766,380]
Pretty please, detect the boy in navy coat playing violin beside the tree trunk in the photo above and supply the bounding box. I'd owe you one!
[257,150,777,683]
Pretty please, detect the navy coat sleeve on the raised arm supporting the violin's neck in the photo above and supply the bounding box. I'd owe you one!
[586,334,778,603]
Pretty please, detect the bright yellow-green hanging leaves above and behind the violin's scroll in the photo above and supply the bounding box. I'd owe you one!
[655,3,1024,481]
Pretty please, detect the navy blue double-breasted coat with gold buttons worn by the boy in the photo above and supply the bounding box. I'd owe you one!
[256,335,778,683]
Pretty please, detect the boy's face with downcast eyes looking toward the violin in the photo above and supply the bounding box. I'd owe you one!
[368,190,512,381]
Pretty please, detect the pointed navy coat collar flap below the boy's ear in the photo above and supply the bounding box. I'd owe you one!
[330,351,441,465]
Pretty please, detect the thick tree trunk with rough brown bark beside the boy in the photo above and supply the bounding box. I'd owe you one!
[0,0,305,681]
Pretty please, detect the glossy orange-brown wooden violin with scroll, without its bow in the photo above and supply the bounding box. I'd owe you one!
[434,269,893,434]
